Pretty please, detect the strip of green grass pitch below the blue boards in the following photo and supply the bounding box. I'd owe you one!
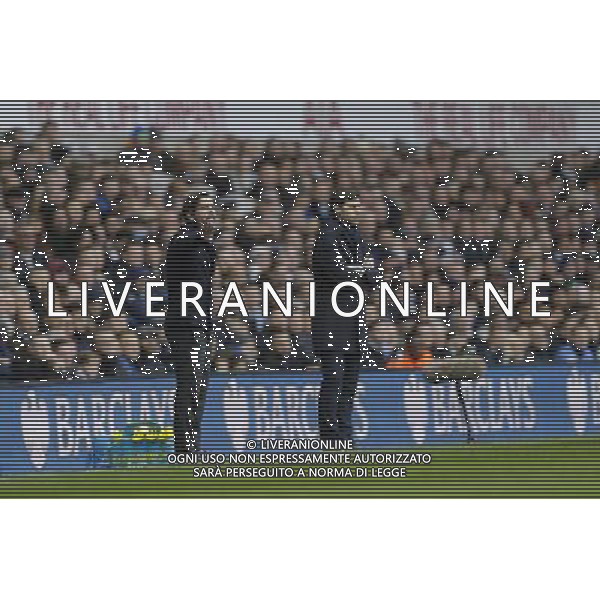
[0,437,600,498]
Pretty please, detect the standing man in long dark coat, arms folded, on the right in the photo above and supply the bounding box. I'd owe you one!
[312,200,374,440]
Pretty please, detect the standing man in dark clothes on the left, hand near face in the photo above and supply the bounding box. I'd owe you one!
[164,196,216,453]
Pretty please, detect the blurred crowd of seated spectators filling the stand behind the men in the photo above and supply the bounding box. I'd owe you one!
[0,123,600,381]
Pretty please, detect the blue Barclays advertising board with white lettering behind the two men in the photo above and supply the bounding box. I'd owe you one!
[0,365,600,473]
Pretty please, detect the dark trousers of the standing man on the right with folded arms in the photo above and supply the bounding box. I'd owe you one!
[318,343,361,440]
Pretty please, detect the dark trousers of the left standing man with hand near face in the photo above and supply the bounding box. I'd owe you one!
[165,321,210,453]
